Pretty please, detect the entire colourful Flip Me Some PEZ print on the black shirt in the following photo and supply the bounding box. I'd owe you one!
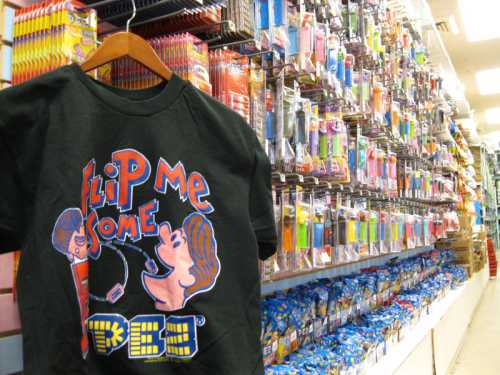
[52,148,220,359]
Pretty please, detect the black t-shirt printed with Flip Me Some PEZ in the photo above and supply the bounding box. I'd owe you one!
[0,65,276,375]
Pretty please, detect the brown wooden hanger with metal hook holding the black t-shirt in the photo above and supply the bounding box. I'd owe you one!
[80,0,173,81]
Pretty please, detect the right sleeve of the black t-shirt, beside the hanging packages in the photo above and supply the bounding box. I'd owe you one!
[250,141,277,260]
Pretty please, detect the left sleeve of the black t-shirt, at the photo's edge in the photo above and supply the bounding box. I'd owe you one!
[0,78,49,253]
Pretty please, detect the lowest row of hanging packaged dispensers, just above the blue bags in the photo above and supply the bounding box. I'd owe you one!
[261,169,460,288]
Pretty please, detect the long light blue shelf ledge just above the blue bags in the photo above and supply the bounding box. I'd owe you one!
[261,246,434,295]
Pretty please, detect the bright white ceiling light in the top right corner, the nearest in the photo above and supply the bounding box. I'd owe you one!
[458,0,500,42]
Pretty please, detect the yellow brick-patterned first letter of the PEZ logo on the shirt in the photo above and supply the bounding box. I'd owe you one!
[87,314,129,356]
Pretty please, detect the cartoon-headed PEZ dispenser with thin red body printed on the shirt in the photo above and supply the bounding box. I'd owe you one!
[52,208,89,358]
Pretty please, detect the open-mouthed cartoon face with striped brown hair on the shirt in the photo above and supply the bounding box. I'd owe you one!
[142,213,220,311]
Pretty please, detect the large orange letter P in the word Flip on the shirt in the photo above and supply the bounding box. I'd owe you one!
[112,148,151,212]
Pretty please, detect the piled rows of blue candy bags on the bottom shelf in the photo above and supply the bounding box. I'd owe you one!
[261,251,467,375]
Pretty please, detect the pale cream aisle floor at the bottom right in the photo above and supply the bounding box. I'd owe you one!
[450,279,500,375]
